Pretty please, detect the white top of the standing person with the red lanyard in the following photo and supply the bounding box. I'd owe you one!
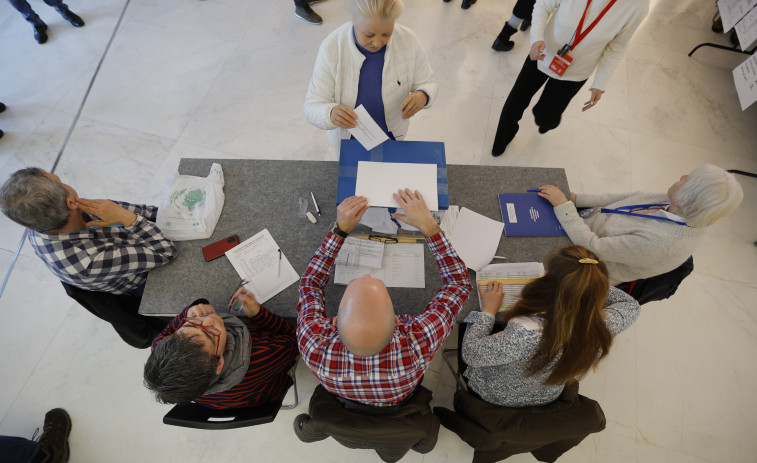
[531,0,649,90]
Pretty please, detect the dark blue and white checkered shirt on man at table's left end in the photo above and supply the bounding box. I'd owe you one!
[29,201,177,294]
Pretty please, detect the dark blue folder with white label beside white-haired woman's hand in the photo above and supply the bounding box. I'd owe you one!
[499,193,566,236]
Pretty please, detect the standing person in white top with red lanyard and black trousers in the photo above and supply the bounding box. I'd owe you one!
[492,0,649,156]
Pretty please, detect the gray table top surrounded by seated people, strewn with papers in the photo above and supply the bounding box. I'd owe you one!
[139,159,570,319]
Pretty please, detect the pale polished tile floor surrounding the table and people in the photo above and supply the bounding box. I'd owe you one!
[0,0,757,463]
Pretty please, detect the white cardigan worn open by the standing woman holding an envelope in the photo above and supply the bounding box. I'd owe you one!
[302,23,437,154]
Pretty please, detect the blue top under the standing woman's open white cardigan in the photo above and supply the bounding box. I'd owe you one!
[352,27,394,140]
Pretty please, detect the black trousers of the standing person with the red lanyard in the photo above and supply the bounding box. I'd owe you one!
[494,57,586,147]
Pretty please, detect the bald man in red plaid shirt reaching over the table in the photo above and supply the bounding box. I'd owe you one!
[297,189,471,407]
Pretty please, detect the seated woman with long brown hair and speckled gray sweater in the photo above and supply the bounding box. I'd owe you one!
[462,246,639,407]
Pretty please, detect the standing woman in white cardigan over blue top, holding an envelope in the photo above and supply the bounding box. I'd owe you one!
[303,0,437,153]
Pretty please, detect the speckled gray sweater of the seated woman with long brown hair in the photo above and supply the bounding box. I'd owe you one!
[462,287,640,407]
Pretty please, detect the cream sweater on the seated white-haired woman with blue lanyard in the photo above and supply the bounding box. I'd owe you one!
[554,192,705,286]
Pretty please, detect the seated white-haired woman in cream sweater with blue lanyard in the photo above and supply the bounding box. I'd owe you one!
[539,164,744,286]
